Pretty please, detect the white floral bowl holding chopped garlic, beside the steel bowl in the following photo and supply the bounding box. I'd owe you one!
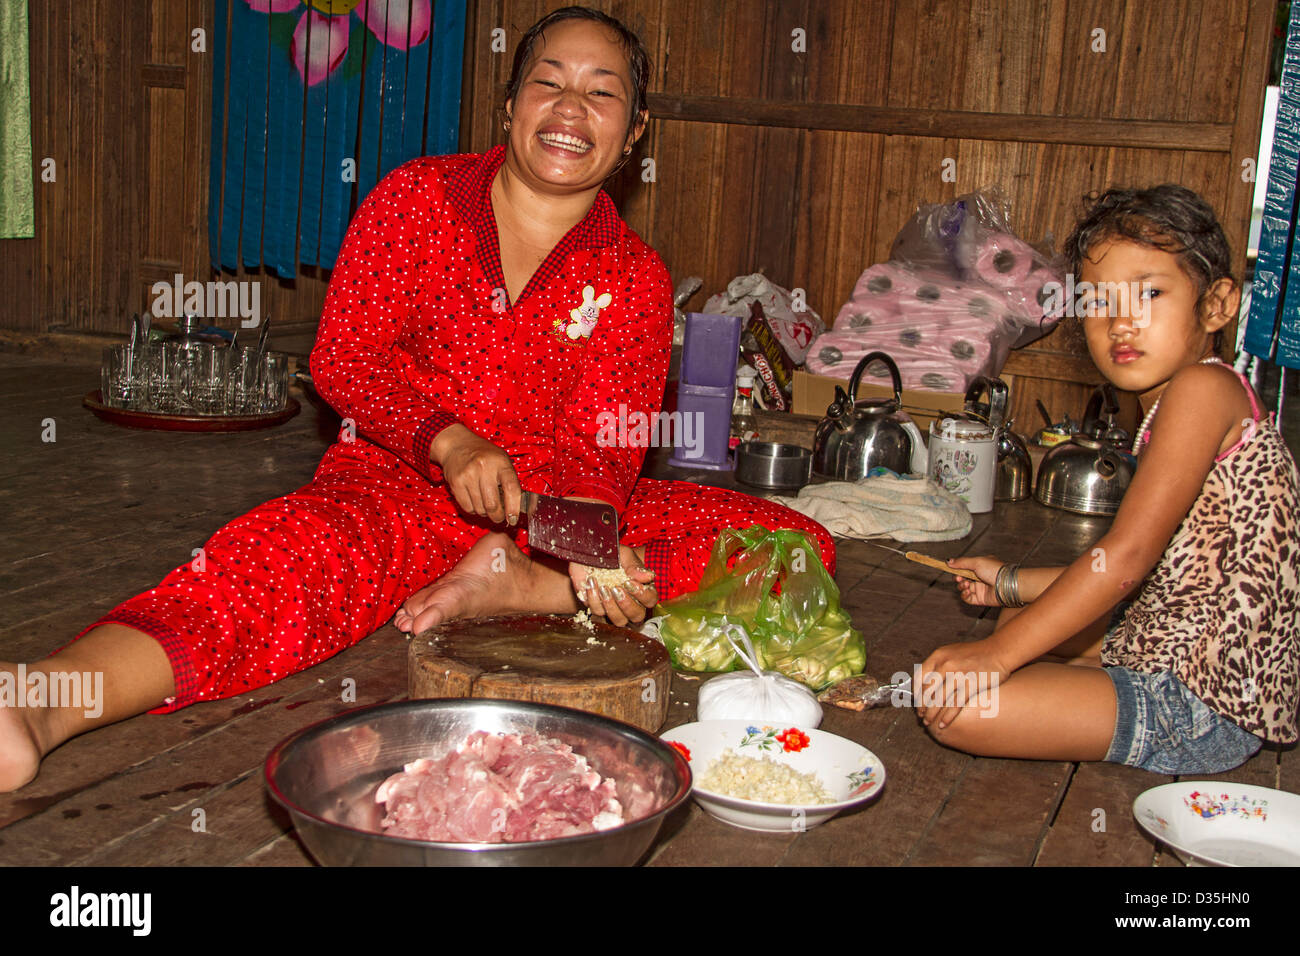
[660,721,885,831]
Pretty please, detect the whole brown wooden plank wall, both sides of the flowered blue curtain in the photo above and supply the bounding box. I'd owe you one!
[0,0,1275,423]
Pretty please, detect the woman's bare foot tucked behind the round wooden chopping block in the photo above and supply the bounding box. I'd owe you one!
[393,532,579,633]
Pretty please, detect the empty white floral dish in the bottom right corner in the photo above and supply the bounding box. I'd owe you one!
[1134,780,1300,866]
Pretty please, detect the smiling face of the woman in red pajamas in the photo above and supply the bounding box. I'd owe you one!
[506,20,645,191]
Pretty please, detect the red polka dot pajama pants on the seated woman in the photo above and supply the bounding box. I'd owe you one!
[78,442,835,713]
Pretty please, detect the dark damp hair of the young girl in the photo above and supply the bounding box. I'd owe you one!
[1065,182,1236,350]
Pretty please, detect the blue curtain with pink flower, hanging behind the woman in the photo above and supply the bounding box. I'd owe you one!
[208,0,465,278]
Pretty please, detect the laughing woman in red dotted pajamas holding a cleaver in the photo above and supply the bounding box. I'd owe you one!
[0,8,835,791]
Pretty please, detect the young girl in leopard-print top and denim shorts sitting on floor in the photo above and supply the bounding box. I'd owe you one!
[917,185,1300,774]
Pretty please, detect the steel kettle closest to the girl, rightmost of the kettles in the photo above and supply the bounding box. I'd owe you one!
[1034,384,1138,515]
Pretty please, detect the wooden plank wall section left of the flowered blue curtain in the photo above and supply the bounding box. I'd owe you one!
[0,0,328,334]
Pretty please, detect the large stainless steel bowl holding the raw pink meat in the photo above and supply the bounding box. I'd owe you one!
[265,700,690,866]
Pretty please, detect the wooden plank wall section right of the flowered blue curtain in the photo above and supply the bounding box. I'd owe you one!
[462,0,1275,428]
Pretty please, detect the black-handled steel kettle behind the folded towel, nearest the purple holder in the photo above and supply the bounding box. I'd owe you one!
[813,352,924,481]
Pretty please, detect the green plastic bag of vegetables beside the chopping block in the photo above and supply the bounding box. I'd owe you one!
[655,524,867,691]
